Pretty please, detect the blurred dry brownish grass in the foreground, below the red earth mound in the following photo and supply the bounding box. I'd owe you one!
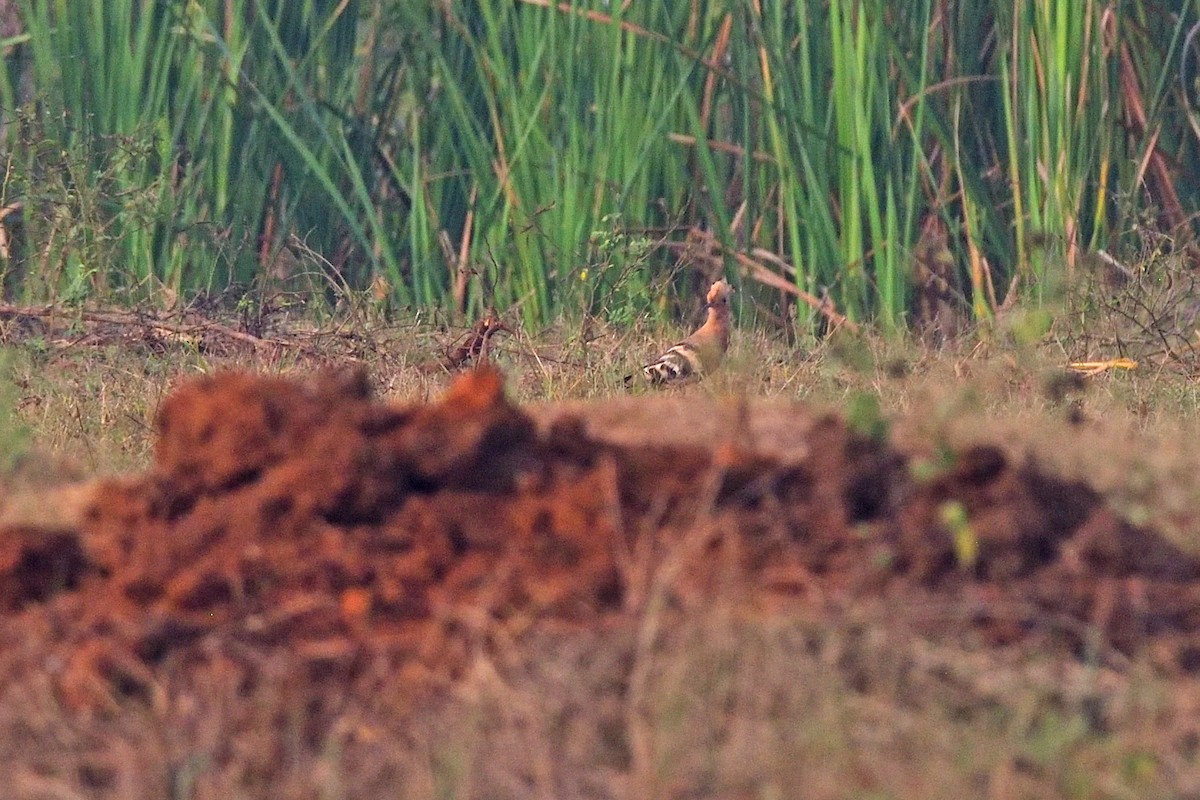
[0,587,1200,800]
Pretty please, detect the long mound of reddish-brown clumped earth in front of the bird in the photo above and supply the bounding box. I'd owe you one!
[0,368,1200,714]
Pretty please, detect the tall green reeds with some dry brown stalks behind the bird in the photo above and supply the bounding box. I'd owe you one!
[0,0,1200,330]
